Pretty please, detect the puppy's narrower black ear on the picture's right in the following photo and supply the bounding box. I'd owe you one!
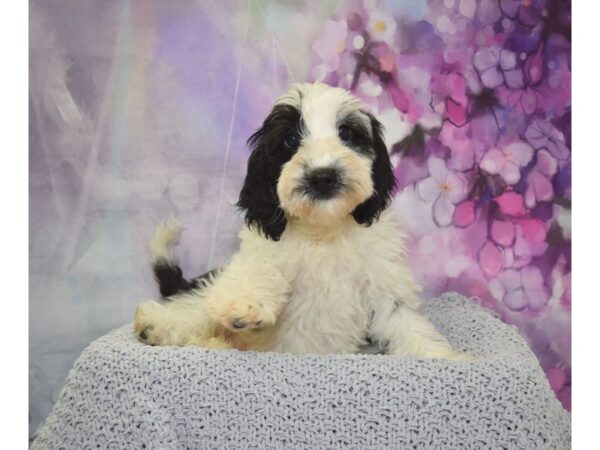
[352,114,396,226]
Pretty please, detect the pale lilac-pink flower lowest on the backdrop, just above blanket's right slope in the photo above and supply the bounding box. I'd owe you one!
[490,266,550,311]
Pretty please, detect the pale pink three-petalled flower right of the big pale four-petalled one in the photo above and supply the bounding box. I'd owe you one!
[479,142,533,185]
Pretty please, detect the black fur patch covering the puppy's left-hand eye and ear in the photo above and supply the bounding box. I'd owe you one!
[237,105,303,241]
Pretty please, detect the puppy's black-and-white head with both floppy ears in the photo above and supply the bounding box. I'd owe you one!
[238,84,396,240]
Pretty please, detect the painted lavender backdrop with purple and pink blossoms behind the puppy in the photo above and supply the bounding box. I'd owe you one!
[29,0,571,432]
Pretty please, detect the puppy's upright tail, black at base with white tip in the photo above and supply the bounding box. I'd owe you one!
[149,217,193,297]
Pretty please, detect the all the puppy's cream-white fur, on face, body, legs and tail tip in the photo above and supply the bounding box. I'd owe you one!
[135,84,465,359]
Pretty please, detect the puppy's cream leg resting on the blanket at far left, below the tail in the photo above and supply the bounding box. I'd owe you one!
[134,294,231,348]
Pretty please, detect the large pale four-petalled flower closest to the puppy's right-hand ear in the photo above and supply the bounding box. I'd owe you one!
[416,157,467,227]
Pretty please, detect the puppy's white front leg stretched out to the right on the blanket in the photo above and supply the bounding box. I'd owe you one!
[370,299,472,360]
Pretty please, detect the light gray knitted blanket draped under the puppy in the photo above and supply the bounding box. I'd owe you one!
[32,294,571,450]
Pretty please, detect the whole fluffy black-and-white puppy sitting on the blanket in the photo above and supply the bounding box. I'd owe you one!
[134,84,465,359]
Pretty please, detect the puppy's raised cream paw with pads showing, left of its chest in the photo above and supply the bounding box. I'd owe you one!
[207,300,275,331]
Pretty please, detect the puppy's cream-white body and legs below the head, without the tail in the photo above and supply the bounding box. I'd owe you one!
[137,210,464,358]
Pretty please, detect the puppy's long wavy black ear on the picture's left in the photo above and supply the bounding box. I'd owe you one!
[237,119,287,241]
